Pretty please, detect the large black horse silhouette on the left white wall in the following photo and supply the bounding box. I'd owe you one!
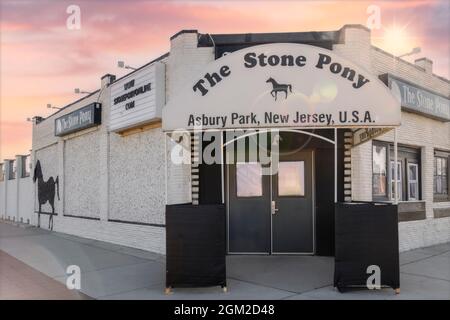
[33,160,59,230]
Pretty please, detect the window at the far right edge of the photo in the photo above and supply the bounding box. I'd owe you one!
[433,151,450,201]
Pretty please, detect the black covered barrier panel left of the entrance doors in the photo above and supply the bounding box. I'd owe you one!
[166,204,226,288]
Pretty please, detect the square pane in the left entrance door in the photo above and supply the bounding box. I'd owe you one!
[236,162,262,197]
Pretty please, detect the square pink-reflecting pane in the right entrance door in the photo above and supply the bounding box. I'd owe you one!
[278,161,305,196]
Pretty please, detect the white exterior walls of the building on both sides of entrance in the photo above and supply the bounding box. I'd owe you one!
[0,26,450,253]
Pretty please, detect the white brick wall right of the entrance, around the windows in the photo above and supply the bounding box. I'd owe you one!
[342,28,450,251]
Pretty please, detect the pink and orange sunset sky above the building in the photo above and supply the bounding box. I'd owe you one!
[0,0,450,162]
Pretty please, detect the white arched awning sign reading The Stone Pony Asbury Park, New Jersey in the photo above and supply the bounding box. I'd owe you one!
[163,44,401,130]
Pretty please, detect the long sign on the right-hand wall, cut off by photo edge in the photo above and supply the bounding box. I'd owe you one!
[384,74,450,122]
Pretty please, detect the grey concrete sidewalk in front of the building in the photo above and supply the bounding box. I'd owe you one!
[0,221,450,300]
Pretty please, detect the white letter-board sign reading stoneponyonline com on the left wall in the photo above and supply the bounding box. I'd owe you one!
[109,62,166,131]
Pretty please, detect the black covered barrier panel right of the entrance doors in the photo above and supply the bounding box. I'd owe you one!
[334,202,400,291]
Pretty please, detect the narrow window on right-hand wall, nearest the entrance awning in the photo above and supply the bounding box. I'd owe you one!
[372,144,387,198]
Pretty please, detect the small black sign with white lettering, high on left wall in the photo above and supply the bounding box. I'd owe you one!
[55,102,102,137]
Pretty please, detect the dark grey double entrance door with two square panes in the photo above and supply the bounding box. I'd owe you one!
[227,150,314,254]
